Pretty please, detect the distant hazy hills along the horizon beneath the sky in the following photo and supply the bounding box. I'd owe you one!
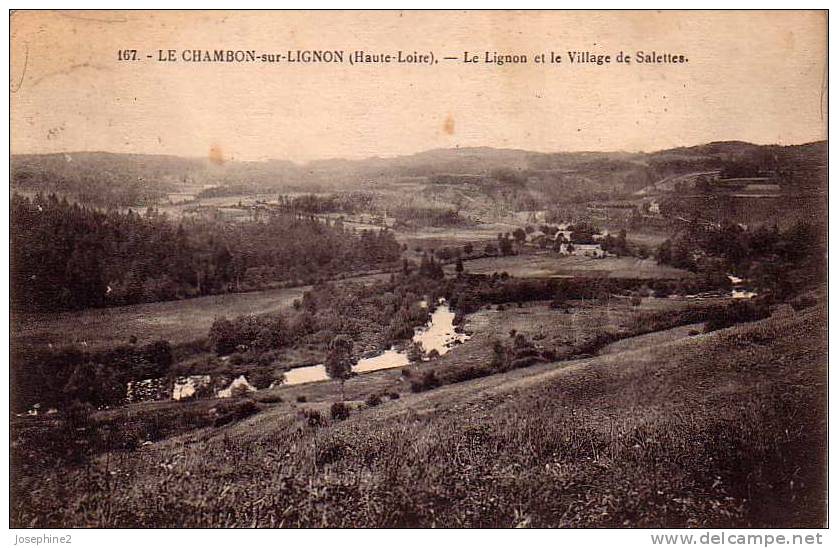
[11,141,827,206]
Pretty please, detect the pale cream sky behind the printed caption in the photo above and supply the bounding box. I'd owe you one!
[10,11,827,162]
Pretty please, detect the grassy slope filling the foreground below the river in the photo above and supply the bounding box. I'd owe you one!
[12,309,826,527]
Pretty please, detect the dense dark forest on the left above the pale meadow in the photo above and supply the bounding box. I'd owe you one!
[11,194,401,311]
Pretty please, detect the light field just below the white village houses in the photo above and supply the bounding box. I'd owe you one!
[449,252,692,279]
